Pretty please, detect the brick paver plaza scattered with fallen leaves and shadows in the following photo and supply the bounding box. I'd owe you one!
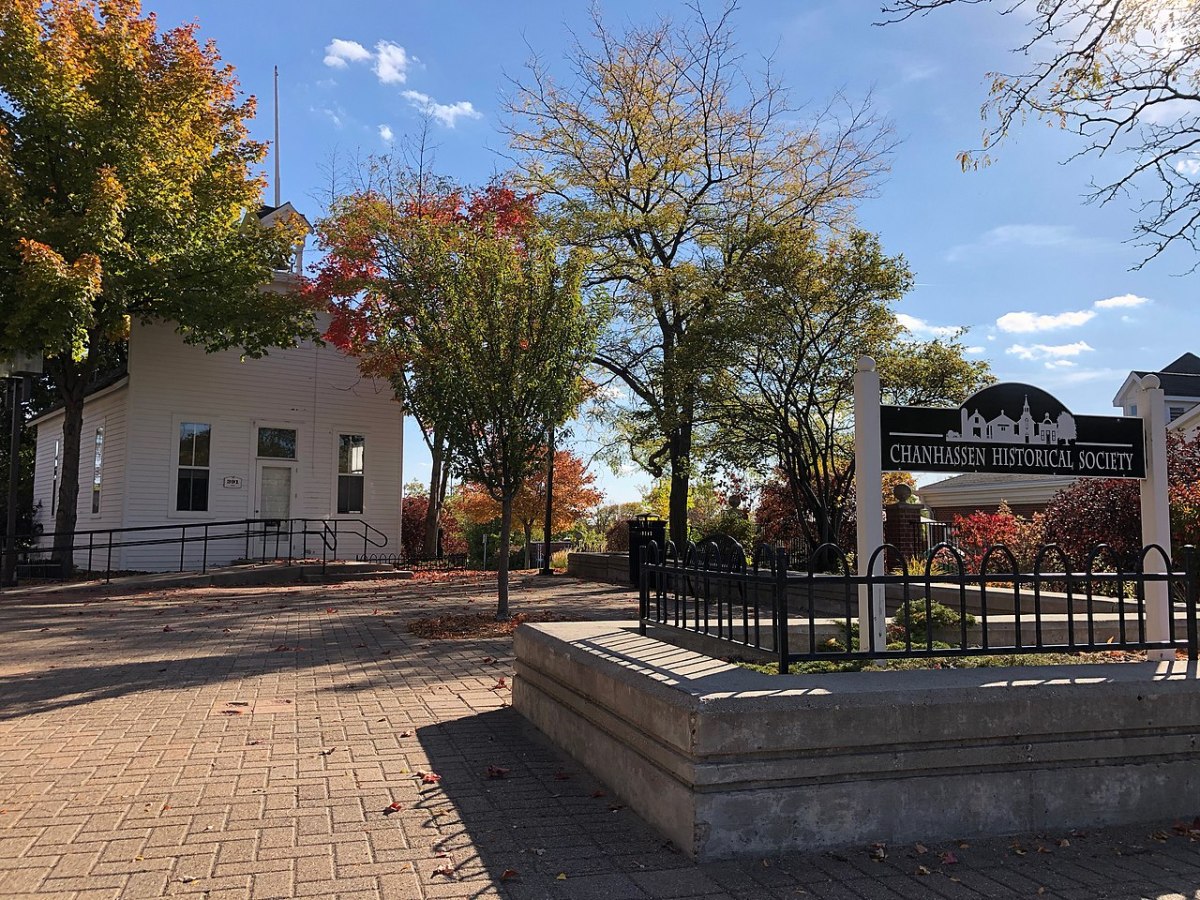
[0,578,1200,900]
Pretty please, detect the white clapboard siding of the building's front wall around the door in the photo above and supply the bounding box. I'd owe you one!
[124,324,403,569]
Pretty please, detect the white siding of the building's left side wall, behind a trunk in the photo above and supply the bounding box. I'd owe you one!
[34,388,128,570]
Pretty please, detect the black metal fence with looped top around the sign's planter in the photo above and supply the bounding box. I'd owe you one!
[641,539,1200,672]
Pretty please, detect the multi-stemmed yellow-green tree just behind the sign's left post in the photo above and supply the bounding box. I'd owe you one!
[720,228,988,546]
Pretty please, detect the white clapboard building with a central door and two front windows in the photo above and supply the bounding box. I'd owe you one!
[27,207,403,571]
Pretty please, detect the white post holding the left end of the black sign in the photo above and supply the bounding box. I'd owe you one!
[854,356,887,649]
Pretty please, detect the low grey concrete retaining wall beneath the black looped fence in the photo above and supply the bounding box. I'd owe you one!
[514,623,1200,859]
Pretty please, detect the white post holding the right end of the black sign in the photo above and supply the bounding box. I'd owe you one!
[1138,374,1175,661]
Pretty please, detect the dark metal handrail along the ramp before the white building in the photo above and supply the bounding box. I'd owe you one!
[16,517,388,582]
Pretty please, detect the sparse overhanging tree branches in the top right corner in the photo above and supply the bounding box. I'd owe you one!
[883,0,1200,265]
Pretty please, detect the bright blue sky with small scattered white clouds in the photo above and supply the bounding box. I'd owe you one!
[146,0,1200,502]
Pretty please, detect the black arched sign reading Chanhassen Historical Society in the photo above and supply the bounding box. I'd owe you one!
[880,384,1146,478]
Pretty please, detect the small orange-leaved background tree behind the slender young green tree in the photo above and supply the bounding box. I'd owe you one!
[460,449,604,569]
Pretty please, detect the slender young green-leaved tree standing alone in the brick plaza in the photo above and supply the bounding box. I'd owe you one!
[408,210,596,619]
